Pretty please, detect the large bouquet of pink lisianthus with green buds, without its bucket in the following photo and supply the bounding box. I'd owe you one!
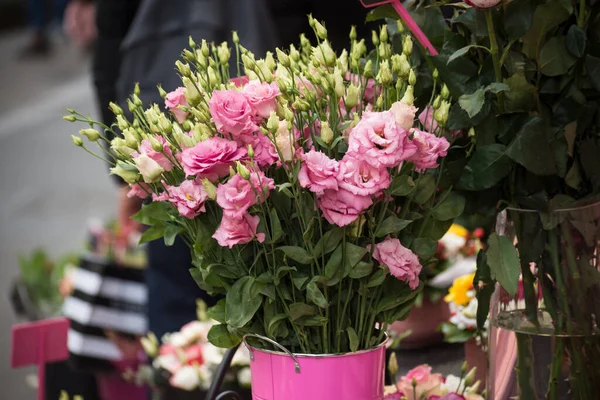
[65,17,464,354]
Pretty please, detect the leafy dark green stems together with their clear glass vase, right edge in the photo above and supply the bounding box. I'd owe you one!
[366,0,600,399]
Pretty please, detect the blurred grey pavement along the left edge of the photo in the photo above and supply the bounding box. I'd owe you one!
[0,32,116,400]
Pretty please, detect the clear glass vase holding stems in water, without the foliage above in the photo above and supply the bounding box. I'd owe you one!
[488,202,600,400]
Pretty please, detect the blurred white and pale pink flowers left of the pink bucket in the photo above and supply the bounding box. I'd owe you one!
[136,301,250,391]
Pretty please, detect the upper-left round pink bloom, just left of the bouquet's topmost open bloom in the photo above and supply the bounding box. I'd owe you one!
[208,90,258,137]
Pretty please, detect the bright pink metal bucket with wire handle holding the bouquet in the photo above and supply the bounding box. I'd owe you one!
[244,335,385,400]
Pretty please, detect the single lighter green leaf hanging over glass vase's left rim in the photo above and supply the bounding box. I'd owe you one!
[487,233,521,297]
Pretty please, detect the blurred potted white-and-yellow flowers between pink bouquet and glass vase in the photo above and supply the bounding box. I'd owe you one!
[390,224,483,349]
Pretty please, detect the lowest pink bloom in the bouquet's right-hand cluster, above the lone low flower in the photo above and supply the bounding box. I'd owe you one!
[317,189,373,226]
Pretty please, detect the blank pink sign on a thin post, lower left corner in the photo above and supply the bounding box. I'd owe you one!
[10,317,69,400]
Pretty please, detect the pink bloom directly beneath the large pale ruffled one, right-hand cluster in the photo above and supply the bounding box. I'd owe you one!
[338,155,392,196]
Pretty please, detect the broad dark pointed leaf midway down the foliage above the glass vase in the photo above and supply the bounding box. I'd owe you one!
[506,117,557,175]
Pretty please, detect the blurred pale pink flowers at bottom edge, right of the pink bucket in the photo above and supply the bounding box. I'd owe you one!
[383,354,484,400]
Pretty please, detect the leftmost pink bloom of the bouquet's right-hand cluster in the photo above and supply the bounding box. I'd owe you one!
[298,149,339,193]
